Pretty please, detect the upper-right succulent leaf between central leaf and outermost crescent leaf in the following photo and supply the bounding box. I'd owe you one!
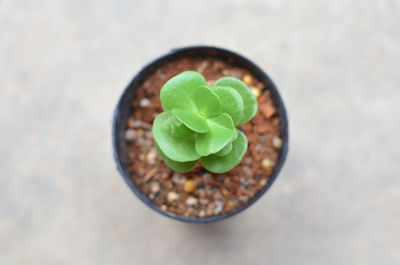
[213,86,244,125]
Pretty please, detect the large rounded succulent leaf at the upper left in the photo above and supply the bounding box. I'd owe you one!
[160,71,207,110]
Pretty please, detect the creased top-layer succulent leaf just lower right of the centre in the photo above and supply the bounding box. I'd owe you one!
[195,113,235,156]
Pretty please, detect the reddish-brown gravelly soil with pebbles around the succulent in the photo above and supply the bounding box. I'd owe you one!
[125,58,282,218]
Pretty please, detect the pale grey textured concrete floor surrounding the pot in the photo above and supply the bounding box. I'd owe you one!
[0,0,400,265]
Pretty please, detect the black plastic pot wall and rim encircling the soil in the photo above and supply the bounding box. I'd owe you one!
[112,46,288,223]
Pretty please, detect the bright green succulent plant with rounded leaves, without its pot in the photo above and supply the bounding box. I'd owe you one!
[153,71,257,173]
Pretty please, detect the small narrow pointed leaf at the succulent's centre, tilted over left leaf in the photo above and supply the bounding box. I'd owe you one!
[171,109,210,133]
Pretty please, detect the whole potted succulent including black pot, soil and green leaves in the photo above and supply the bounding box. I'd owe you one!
[113,46,288,222]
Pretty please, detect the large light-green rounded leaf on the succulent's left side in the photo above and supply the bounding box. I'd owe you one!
[153,111,200,162]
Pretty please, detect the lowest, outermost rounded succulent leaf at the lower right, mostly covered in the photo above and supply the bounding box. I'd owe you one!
[201,128,247,173]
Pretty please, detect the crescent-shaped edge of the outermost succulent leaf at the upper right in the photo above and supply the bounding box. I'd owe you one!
[214,76,257,124]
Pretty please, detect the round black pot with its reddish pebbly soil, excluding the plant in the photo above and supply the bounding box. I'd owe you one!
[112,46,288,223]
